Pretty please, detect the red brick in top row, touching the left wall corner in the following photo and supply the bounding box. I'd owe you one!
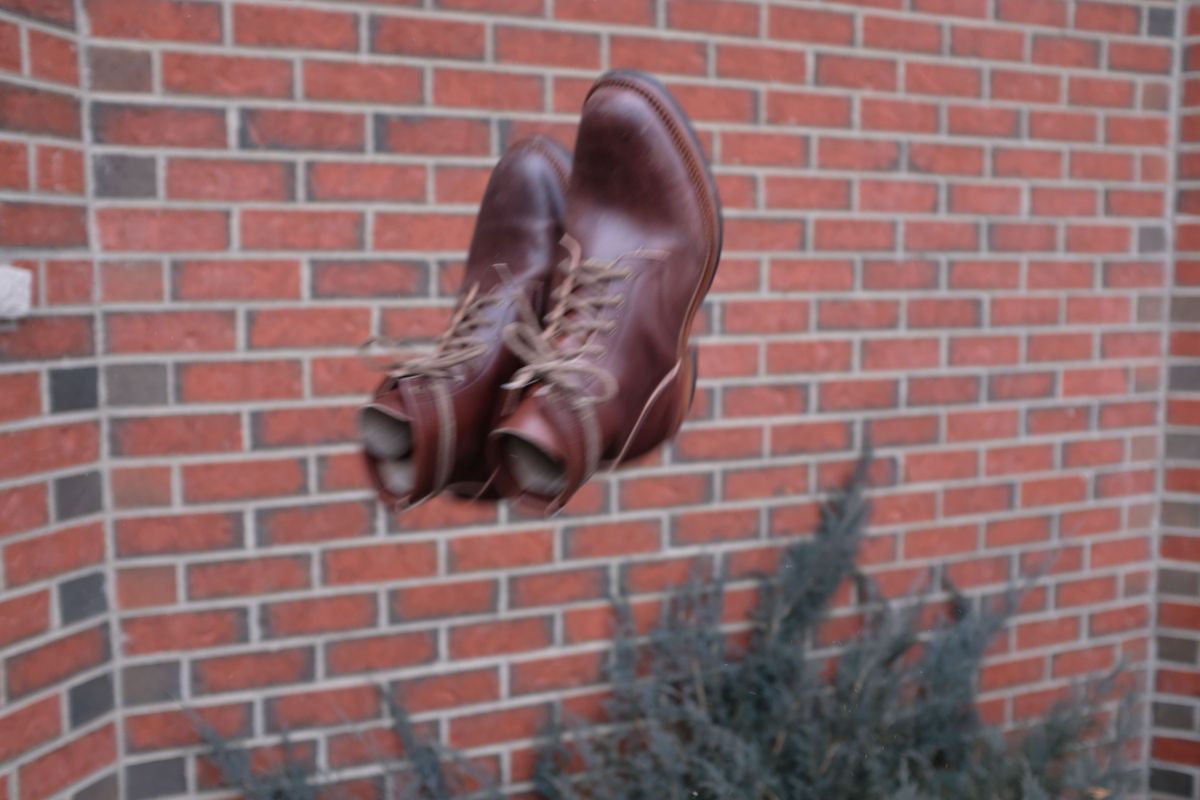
[86,0,221,44]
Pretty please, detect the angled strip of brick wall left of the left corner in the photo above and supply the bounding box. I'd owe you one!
[0,0,118,800]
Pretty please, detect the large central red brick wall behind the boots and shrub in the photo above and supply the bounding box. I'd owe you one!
[0,0,1195,798]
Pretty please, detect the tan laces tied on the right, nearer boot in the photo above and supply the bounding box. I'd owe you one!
[504,235,667,403]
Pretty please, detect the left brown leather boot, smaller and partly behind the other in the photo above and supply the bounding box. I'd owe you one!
[359,137,570,509]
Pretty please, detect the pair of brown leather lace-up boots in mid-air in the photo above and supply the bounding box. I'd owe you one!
[360,71,721,513]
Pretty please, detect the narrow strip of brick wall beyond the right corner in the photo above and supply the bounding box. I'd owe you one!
[1151,4,1200,798]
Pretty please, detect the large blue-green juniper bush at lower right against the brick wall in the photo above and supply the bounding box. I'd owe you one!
[536,457,1134,800]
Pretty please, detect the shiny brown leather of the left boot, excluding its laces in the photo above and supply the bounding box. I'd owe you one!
[366,137,570,506]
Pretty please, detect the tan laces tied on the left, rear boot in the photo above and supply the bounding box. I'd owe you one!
[362,280,499,379]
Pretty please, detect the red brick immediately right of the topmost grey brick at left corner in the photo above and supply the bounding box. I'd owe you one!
[162,53,292,97]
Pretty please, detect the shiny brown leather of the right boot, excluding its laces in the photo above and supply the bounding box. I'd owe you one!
[492,72,720,511]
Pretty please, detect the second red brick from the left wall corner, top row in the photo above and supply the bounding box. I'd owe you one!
[233,4,359,50]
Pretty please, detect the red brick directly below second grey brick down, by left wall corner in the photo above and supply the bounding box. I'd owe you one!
[96,209,229,252]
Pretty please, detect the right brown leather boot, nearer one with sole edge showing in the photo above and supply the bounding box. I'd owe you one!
[488,71,721,513]
